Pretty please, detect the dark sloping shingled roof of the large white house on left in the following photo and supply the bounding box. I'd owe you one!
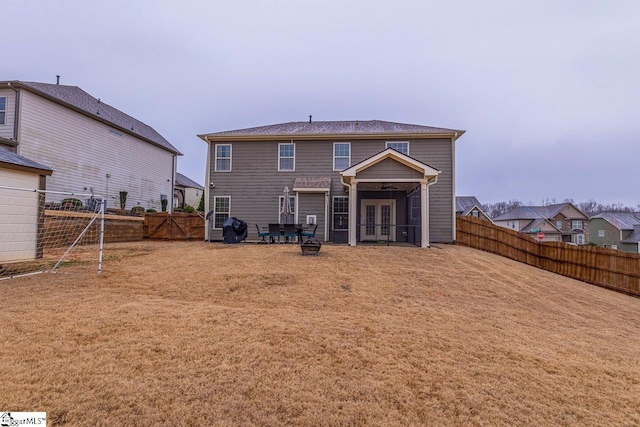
[0,81,181,155]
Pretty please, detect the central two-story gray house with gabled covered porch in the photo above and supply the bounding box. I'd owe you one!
[199,119,464,247]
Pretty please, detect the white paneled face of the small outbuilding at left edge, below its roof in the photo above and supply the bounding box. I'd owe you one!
[0,168,39,262]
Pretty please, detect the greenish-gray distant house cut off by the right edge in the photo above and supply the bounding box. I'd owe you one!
[589,212,640,253]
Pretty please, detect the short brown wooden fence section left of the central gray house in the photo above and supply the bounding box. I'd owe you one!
[144,212,204,240]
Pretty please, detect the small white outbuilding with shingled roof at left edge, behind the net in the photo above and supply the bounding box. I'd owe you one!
[0,147,52,262]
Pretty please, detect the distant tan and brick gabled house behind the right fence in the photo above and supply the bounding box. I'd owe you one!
[493,203,589,245]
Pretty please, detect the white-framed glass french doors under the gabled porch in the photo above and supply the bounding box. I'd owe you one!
[360,199,396,242]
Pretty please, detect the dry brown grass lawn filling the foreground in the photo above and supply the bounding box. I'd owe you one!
[0,242,640,426]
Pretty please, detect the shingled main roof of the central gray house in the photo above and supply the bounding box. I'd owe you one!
[198,120,465,142]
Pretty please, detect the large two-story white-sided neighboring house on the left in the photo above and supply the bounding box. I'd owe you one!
[0,81,181,210]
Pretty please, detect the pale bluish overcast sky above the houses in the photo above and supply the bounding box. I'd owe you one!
[6,0,640,206]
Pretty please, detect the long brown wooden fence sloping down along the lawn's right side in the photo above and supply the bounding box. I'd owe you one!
[456,216,640,296]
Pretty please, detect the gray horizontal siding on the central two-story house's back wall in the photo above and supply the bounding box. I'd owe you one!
[208,138,454,243]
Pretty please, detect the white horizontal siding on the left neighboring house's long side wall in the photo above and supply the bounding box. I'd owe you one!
[18,91,174,210]
